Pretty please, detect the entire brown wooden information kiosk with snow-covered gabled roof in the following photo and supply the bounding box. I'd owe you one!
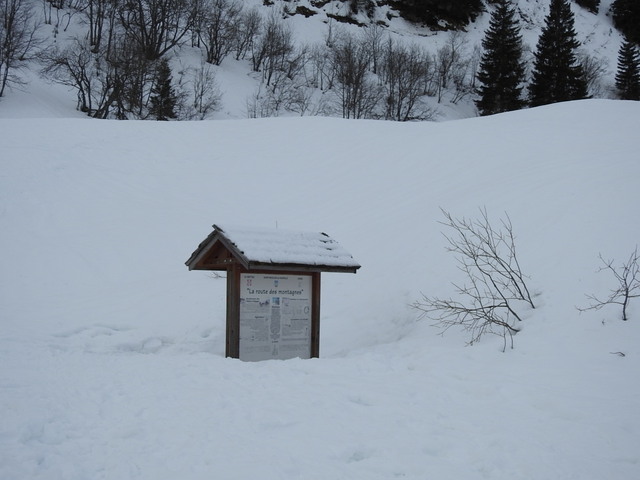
[186,225,360,361]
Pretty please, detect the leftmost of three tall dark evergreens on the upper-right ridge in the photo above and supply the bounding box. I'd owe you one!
[476,0,525,115]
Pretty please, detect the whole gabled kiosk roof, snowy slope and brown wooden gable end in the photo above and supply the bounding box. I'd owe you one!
[186,225,360,273]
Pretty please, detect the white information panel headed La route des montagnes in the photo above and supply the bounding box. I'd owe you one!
[240,273,312,361]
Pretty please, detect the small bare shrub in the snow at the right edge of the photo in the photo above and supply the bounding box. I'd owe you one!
[578,246,640,321]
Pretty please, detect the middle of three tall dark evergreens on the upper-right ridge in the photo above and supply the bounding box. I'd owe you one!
[529,0,587,106]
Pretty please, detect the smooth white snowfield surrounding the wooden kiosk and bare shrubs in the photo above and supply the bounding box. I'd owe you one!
[0,100,640,480]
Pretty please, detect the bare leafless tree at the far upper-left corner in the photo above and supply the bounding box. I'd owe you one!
[0,0,40,97]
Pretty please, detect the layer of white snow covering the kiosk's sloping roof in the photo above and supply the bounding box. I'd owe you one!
[214,225,360,268]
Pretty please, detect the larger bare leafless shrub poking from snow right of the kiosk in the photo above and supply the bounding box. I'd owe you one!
[413,209,535,348]
